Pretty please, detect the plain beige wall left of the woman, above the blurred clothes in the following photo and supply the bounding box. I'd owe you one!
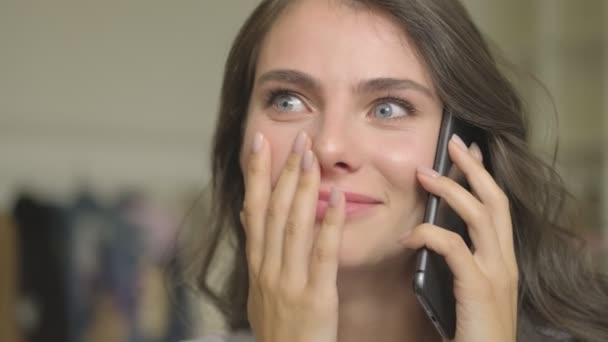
[0,0,257,208]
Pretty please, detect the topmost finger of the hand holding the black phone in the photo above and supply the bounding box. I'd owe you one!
[449,135,516,269]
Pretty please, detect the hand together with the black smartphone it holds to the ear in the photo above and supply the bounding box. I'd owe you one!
[401,110,519,342]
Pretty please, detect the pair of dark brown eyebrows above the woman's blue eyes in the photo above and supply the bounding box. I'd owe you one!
[257,69,433,98]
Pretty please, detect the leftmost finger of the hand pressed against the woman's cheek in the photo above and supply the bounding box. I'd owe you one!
[241,132,271,274]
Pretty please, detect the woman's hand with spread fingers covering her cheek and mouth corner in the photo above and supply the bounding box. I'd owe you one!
[241,133,344,342]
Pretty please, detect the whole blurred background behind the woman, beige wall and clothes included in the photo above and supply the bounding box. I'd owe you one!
[0,0,608,341]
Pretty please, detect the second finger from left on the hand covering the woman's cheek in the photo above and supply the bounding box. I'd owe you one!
[260,132,308,278]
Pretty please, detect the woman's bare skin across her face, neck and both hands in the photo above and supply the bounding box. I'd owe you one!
[240,0,517,342]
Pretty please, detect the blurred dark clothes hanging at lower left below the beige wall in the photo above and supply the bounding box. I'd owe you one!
[0,191,196,342]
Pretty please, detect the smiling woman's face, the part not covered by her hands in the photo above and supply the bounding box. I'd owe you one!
[240,0,442,267]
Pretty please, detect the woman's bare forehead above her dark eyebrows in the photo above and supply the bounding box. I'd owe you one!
[256,0,433,89]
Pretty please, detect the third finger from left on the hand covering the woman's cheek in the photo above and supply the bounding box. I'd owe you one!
[281,150,320,286]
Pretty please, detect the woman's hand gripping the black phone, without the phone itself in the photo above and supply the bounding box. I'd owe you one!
[402,136,518,342]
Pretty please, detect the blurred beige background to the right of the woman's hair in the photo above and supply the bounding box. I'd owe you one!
[464,0,608,235]
